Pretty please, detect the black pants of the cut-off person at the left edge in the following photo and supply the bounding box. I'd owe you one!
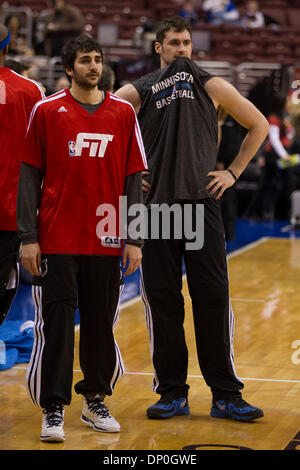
[0,230,19,325]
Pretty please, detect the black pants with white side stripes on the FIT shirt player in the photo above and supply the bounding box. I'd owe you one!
[27,255,124,408]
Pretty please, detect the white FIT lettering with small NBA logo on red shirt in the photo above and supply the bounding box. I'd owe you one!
[68,132,114,158]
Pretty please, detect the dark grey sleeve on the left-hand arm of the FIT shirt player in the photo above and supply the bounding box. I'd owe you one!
[17,162,43,245]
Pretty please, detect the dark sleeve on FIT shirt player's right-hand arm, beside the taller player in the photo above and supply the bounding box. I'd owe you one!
[124,172,144,248]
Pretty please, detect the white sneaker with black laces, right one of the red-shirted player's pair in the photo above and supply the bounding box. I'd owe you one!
[81,393,121,432]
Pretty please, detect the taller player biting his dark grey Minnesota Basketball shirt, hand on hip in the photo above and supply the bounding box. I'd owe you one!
[116,17,268,421]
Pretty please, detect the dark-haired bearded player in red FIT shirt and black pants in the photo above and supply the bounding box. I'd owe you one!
[18,35,147,441]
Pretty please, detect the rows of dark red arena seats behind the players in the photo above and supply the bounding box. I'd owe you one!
[0,0,300,87]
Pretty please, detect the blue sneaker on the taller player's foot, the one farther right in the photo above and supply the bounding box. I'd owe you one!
[210,397,264,423]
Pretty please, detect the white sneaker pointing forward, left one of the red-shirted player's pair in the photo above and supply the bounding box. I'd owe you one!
[41,405,66,442]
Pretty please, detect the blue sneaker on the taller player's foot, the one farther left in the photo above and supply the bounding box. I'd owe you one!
[147,395,190,419]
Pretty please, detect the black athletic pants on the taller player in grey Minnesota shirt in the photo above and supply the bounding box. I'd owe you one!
[141,199,243,399]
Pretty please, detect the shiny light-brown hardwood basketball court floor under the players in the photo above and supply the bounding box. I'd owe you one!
[0,238,300,451]
